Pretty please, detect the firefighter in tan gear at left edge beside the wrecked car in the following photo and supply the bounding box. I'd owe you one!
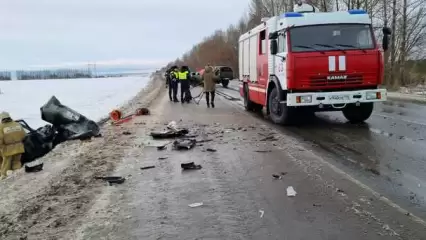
[0,112,25,179]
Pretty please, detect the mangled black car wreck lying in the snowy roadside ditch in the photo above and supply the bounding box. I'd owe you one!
[17,96,100,164]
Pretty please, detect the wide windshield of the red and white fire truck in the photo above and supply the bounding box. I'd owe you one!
[290,24,374,52]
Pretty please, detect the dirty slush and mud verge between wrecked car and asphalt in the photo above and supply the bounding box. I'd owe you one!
[0,76,164,239]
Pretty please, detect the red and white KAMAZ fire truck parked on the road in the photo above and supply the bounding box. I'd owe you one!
[239,4,391,124]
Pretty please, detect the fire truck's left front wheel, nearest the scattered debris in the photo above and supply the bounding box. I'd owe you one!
[268,88,290,124]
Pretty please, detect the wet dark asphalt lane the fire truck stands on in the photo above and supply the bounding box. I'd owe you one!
[218,81,426,223]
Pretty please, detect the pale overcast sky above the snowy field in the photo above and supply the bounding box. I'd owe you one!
[0,0,249,69]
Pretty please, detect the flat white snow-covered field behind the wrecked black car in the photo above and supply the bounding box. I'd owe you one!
[0,76,149,128]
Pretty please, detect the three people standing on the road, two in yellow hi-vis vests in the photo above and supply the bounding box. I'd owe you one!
[166,65,217,108]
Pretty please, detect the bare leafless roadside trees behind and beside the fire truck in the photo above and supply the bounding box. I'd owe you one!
[166,0,426,87]
